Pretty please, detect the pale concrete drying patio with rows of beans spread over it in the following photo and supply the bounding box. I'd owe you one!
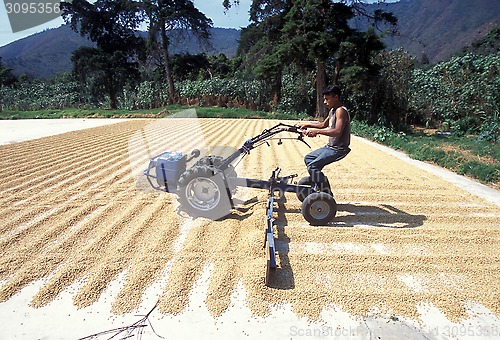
[0,119,500,340]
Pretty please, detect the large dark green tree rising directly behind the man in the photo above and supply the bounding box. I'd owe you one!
[237,0,396,115]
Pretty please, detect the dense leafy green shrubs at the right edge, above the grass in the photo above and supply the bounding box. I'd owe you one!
[410,54,500,139]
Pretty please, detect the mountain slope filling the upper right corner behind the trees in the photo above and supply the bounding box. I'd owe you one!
[369,0,500,63]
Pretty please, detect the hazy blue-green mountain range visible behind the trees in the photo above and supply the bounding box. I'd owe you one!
[0,0,500,77]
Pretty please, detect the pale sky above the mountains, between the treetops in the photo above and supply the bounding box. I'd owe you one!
[0,0,394,46]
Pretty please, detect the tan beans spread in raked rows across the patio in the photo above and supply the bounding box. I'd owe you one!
[0,119,500,320]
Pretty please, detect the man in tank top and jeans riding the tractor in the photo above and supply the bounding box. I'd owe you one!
[298,85,351,192]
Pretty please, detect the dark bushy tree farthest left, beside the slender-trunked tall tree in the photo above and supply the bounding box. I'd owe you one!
[61,0,145,109]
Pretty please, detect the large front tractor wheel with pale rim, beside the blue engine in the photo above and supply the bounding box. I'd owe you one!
[177,166,231,220]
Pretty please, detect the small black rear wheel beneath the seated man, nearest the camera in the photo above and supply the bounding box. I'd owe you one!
[302,192,337,225]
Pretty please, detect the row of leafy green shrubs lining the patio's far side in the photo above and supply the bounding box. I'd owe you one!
[0,51,500,141]
